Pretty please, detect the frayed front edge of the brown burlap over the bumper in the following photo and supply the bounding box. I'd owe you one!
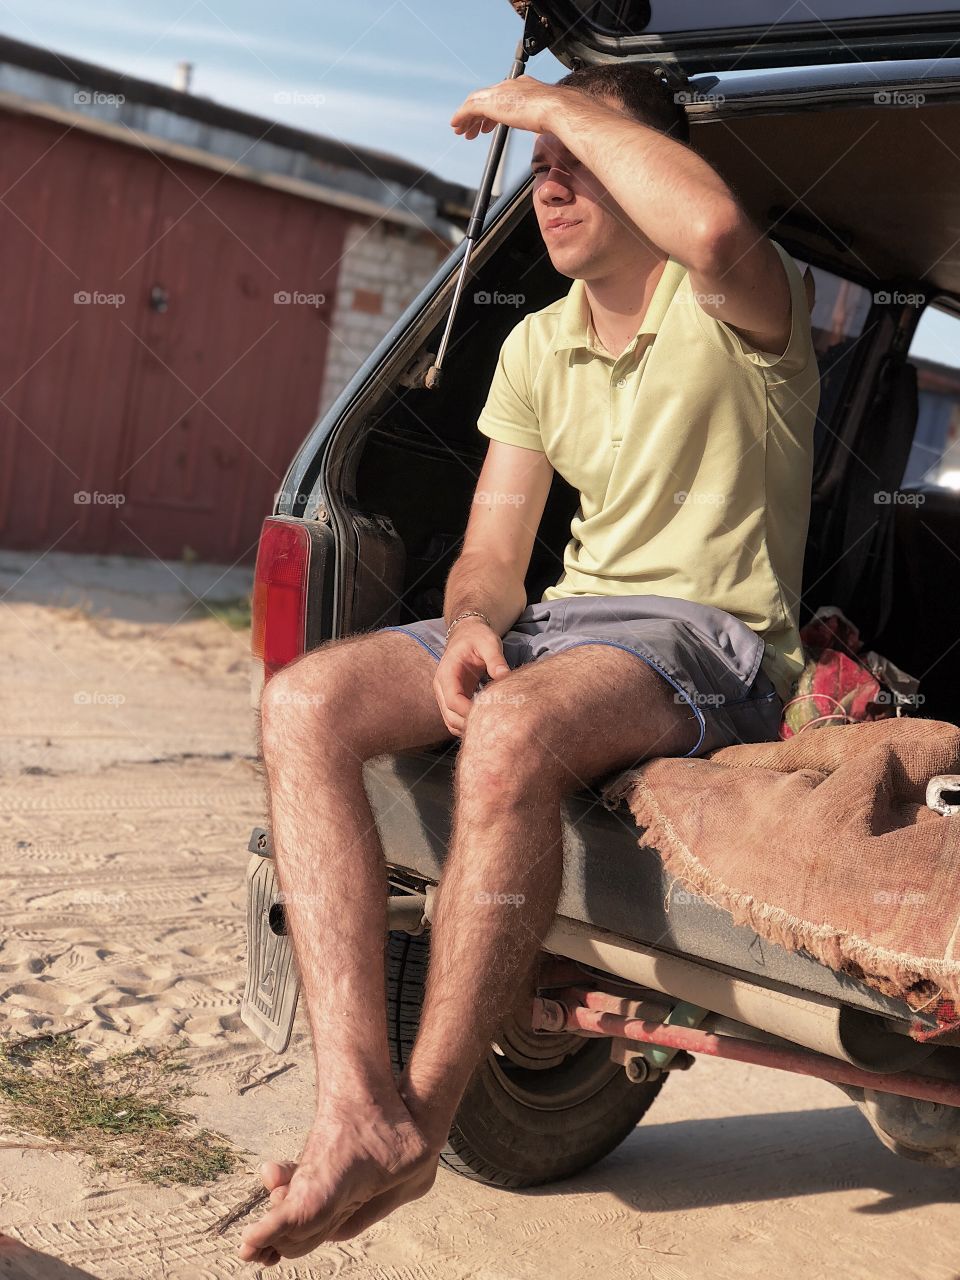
[603,772,960,1012]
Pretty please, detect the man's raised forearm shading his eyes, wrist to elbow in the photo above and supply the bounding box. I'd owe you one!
[550,93,744,274]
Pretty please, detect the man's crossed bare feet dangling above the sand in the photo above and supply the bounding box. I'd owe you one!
[239,1097,439,1266]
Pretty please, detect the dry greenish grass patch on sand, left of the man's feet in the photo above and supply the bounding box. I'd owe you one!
[0,1034,237,1187]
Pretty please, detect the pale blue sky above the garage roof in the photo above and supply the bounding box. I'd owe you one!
[0,0,566,187]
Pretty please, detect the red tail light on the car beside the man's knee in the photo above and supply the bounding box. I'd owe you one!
[252,517,310,680]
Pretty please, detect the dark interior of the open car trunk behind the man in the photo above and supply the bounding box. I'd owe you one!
[340,90,960,719]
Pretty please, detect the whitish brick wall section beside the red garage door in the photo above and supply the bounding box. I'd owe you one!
[319,219,451,415]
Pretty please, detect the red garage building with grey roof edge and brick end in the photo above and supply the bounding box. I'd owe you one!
[0,40,472,563]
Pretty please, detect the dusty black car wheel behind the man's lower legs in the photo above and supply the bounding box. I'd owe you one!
[387,933,667,1187]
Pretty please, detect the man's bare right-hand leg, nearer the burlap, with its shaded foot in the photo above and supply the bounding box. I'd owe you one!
[325,645,698,1239]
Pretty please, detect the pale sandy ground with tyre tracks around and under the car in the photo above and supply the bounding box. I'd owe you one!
[0,553,960,1280]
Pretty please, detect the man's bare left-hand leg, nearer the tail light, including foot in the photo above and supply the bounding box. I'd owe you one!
[241,632,451,1263]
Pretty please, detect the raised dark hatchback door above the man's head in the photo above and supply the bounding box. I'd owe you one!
[529,0,960,76]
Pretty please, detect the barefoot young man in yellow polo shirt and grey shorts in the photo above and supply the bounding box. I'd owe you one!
[241,67,819,1265]
